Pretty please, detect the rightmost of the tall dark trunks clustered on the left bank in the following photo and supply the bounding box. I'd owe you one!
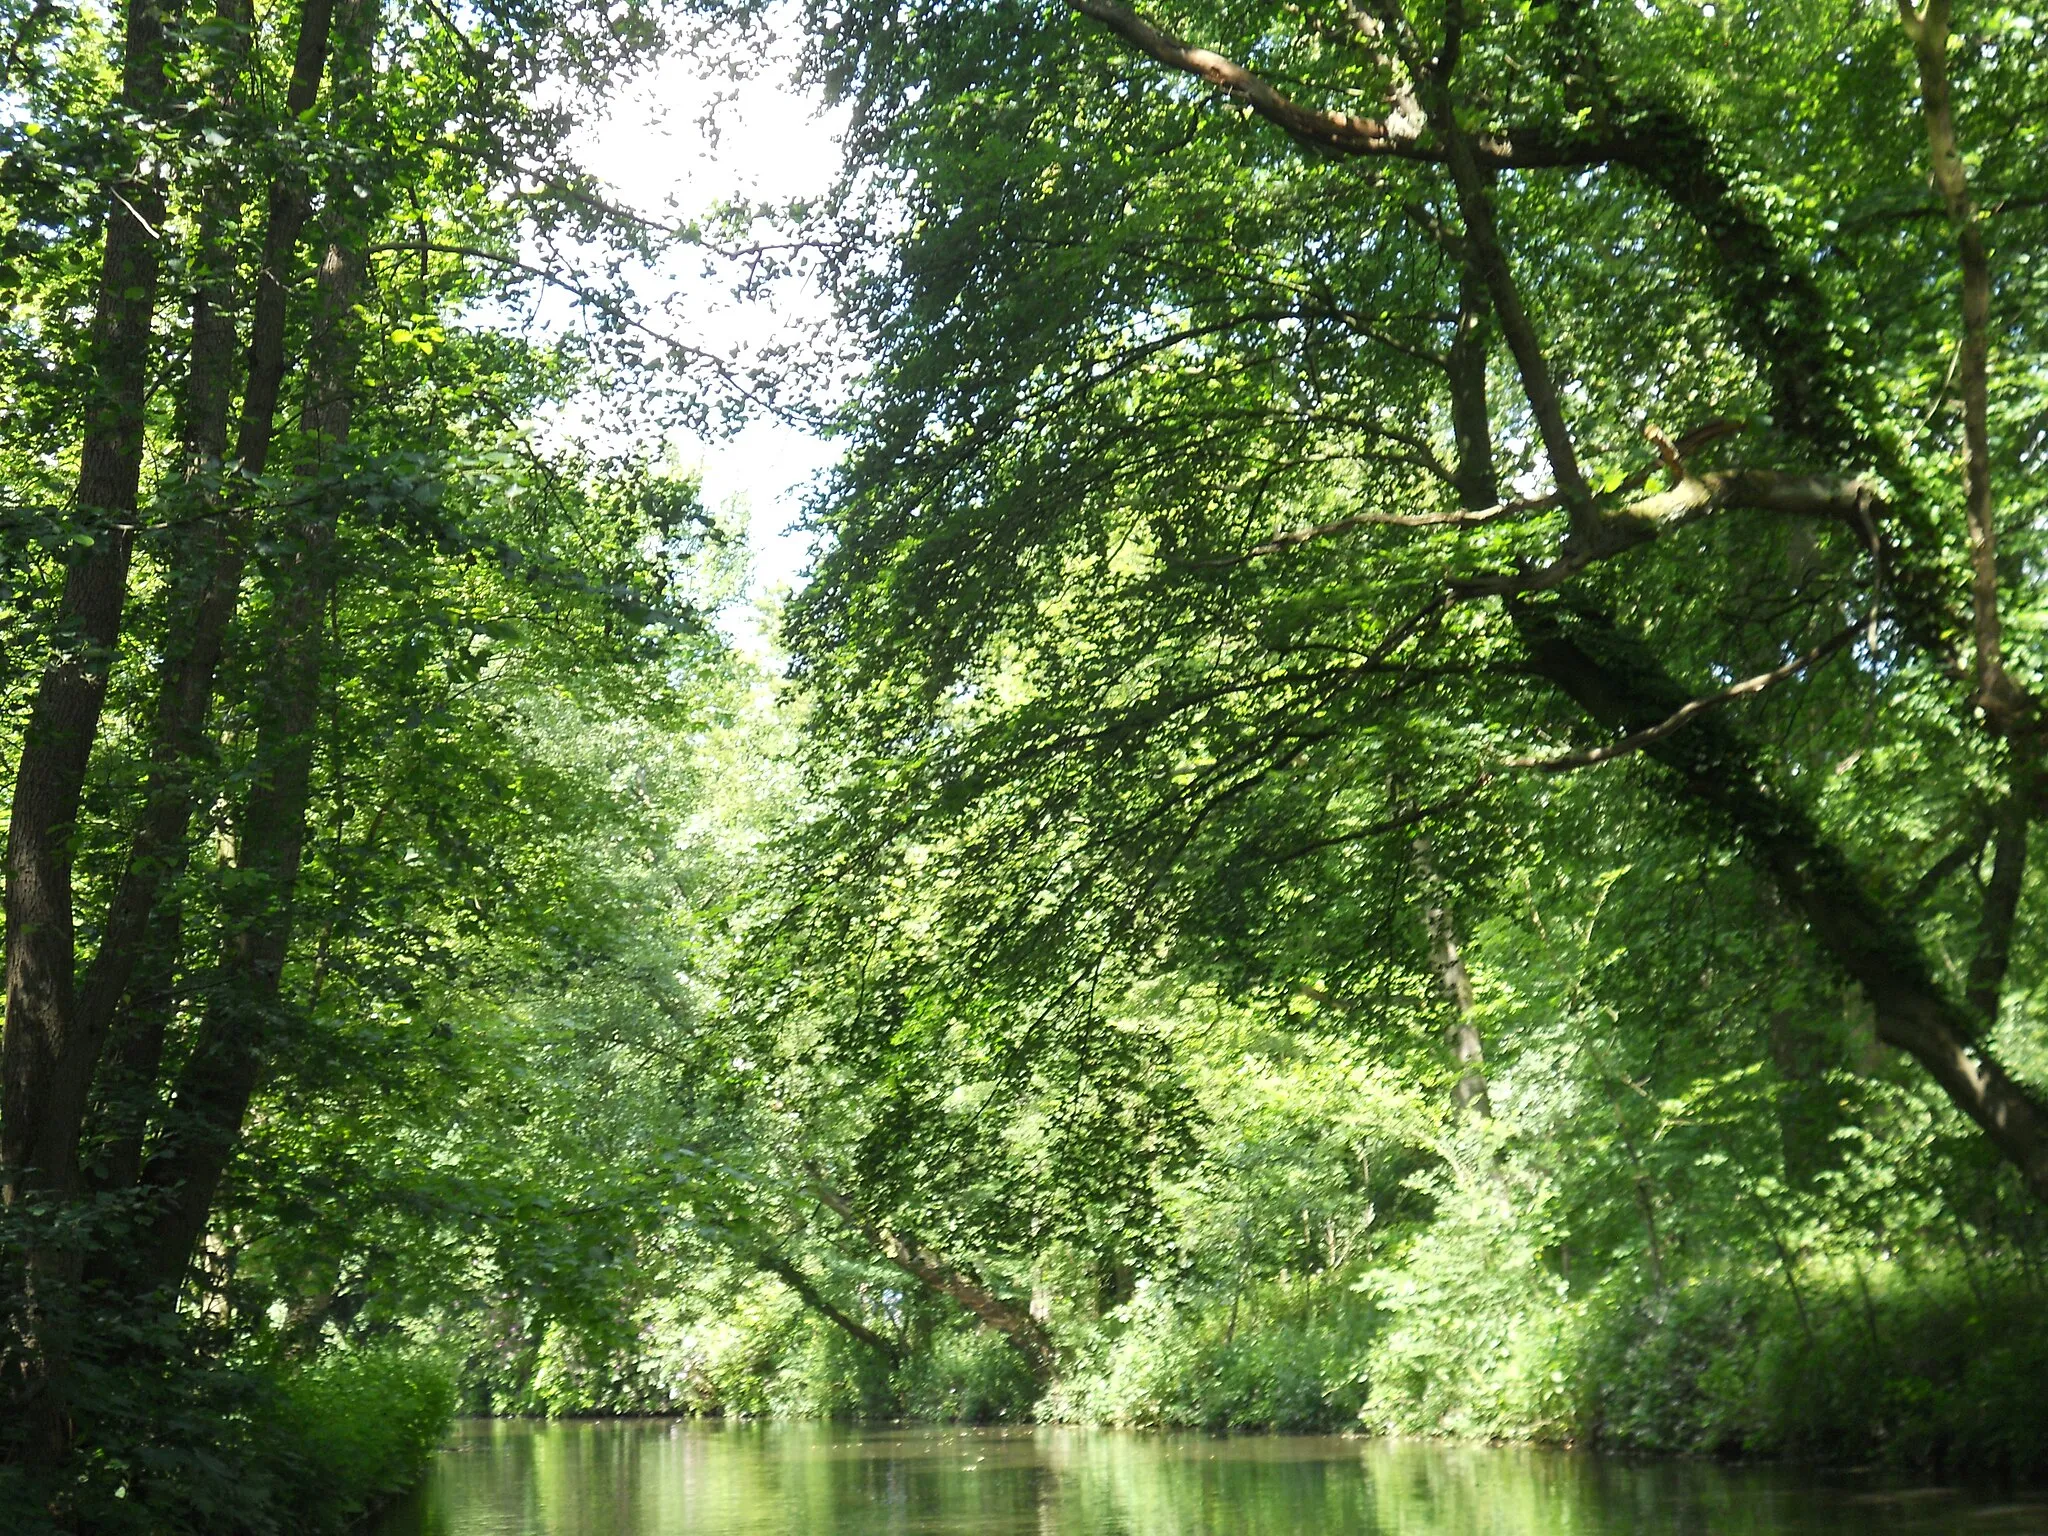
[143,0,381,1292]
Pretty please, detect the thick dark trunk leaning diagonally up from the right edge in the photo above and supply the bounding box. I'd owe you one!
[1509,602,2048,1202]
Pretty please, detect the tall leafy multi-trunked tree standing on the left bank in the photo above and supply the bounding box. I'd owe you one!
[0,0,745,1466]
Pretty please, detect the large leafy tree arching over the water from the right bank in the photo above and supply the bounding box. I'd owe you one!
[770,0,2048,1196]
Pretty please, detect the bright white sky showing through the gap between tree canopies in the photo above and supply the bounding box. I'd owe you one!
[580,36,844,653]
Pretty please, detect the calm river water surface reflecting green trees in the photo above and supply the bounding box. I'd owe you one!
[375,1421,2048,1536]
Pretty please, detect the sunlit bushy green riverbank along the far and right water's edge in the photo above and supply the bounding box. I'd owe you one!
[465,1233,2048,1479]
